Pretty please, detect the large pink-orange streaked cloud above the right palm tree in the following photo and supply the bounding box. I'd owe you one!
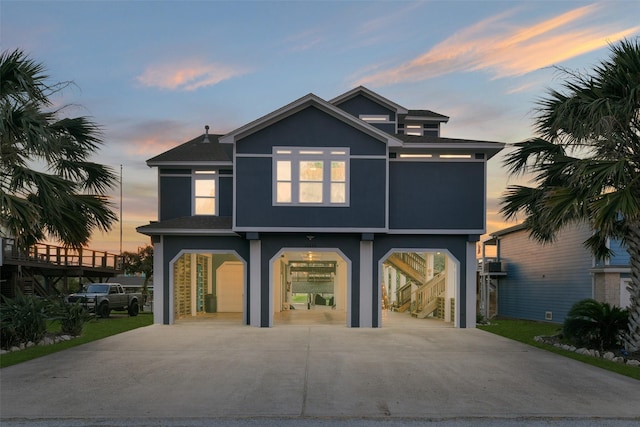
[356,4,640,85]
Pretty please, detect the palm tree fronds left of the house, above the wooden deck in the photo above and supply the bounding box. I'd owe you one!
[0,49,117,248]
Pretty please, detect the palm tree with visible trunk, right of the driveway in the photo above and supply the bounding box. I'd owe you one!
[501,40,640,350]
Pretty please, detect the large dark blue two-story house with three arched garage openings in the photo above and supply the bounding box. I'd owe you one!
[138,87,504,327]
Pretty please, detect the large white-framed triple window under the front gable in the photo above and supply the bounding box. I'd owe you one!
[273,147,349,206]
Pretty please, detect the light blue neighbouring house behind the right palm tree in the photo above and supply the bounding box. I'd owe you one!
[480,224,631,322]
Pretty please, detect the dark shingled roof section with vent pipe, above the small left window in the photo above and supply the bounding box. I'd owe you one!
[147,134,233,166]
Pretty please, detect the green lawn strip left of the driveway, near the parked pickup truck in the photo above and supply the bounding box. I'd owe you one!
[0,313,153,368]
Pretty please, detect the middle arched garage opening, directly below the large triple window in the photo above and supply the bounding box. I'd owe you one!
[272,248,348,325]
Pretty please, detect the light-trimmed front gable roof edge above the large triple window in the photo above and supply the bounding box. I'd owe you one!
[219,93,401,146]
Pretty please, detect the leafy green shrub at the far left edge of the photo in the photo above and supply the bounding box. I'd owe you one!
[0,293,51,344]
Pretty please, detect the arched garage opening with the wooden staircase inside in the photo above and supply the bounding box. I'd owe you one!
[380,251,458,323]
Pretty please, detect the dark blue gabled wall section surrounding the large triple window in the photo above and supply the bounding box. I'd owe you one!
[235,107,387,230]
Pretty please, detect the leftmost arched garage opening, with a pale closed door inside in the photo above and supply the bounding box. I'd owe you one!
[173,252,245,323]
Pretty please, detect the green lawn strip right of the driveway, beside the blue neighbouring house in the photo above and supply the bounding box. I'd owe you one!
[477,319,640,380]
